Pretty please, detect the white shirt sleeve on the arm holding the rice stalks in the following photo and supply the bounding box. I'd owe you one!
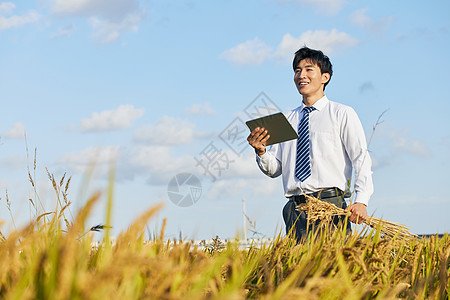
[341,107,373,206]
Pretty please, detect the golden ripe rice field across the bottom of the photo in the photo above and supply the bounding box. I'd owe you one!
[0,170,450,299]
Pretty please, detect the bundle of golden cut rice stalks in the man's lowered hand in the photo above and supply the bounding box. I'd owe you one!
[296,196,417,239]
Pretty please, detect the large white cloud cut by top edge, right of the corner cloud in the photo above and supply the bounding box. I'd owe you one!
[50,0,145,44]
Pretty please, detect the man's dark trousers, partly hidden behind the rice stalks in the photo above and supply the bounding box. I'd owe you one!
[283,196,351,241]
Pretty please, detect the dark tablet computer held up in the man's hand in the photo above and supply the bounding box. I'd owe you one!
[245,112,298,146]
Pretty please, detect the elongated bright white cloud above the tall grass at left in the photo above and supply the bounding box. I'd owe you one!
[80,105,144,132]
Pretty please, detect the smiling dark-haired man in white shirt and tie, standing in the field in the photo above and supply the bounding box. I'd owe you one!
[247,47,373,240]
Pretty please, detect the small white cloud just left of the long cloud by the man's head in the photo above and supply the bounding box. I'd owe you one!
[220,37,273,65]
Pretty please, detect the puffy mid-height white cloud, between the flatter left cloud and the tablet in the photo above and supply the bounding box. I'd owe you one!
[134,116,195,145]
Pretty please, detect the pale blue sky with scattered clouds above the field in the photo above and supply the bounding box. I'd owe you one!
[0,0,450,239]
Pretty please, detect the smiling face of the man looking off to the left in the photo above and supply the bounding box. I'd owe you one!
[294,59,330,99]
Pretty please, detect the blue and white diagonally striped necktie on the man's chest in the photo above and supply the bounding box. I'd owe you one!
[295,106,315,182]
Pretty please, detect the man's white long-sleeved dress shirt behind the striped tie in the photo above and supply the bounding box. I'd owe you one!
[256,96,373,205]
